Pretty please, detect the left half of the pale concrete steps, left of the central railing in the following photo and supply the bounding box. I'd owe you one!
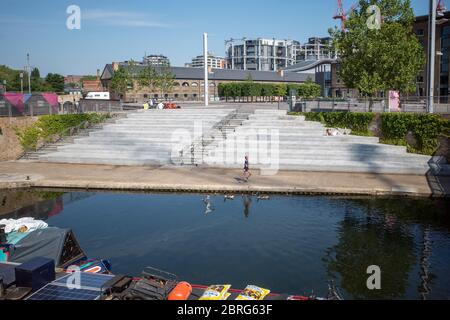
[39,109,235,166]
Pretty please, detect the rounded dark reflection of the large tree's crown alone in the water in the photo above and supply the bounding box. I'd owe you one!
[325,206,416,299]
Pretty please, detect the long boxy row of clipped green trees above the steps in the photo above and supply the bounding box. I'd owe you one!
[218,79,321,101]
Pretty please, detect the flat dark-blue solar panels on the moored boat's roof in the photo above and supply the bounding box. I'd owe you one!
[27,273,114,300]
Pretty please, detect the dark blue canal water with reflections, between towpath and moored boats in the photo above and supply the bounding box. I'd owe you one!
[0,191,450,299]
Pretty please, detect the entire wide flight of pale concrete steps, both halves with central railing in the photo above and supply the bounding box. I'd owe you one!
[39,109,443,175]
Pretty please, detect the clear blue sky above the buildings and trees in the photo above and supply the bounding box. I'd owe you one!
[0,0,428,75]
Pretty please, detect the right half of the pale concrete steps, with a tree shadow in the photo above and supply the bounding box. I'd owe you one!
[203,110,431,174]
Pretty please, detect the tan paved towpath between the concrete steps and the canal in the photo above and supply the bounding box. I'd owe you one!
[0,162,444,197]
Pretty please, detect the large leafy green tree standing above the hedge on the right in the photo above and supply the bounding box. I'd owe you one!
[330,0,425,109]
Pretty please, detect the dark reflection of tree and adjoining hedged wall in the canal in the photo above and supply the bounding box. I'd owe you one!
[324,199,450,299]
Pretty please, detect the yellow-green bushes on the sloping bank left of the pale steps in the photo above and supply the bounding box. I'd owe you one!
[15,113,111,152]
